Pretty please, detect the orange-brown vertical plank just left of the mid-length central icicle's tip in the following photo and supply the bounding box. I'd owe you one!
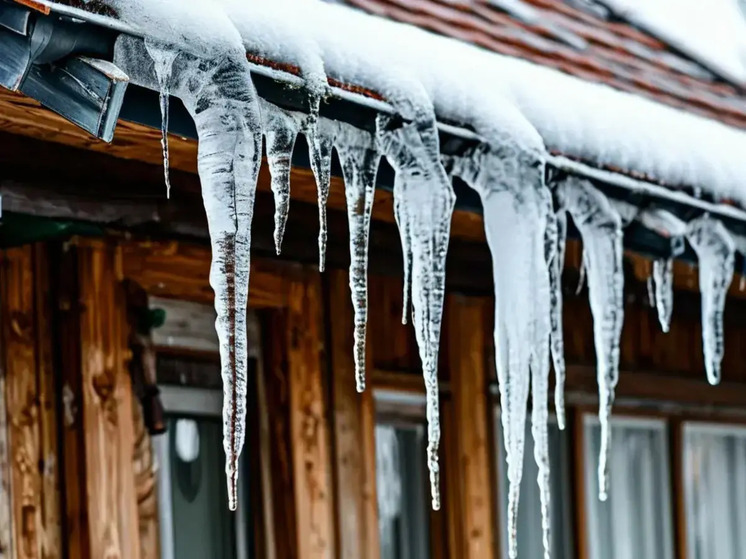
[285,273,335,559]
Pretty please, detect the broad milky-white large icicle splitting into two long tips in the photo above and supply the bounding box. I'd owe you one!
[453,141,550,559]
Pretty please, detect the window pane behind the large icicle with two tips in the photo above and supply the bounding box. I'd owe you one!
[496,414,572,559]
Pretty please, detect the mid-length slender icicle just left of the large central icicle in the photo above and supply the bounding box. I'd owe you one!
[335,124,381,392]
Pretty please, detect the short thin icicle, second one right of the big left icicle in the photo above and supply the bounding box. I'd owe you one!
[308,119,337,272]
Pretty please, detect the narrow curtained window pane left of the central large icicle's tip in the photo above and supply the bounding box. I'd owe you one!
[376,423,430,559]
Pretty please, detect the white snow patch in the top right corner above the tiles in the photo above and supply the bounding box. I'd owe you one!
[604,0,746,85]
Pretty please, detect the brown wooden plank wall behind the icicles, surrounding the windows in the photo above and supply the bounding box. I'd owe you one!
[0,233,746,559]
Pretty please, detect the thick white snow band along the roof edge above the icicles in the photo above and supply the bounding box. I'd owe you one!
[46,0,746,205]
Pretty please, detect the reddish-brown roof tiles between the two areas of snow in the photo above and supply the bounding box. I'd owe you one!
[346,0,746,128]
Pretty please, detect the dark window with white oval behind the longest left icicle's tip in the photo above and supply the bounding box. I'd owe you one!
[154,386,251,559]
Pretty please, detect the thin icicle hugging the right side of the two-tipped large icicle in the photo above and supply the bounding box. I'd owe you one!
[546,208,567,431]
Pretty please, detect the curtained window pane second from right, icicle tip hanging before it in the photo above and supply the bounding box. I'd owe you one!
[584,416,673,559]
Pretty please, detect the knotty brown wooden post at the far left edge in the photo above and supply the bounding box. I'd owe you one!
[0,245,62,559]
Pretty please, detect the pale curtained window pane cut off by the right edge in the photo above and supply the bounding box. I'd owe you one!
[684,424,746,559]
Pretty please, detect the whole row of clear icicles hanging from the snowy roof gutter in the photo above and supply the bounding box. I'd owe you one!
[141,43,735,559]
